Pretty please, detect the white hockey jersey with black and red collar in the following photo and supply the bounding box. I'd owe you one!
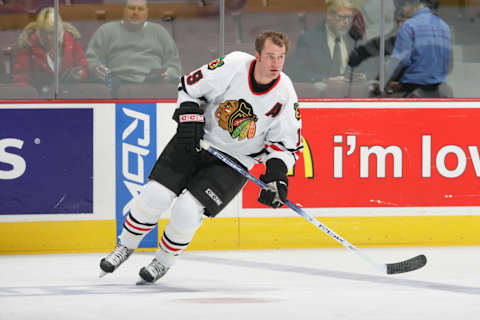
[177,51,303,169]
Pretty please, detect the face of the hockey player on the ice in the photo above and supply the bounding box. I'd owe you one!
[255,38,286,84]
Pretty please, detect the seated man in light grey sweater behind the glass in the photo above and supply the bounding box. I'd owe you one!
[87,0,181,97]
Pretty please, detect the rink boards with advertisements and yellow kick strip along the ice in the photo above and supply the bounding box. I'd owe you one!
[0,99,480,254]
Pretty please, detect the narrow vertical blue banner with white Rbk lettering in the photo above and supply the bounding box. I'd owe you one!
[115,103,158,248]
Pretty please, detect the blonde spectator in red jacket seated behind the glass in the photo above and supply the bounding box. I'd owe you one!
[13,7,87,97]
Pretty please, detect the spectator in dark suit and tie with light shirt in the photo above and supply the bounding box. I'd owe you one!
[287,0,365,96]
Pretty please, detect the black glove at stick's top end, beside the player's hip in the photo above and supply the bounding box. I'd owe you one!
[172,101,205,151]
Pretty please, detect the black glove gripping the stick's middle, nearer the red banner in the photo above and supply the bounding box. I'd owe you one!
[258,158,288,208]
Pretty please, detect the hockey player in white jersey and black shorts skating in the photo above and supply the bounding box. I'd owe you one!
[100,31,302,283]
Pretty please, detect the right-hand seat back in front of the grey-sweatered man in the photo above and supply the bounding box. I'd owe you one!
[117,83,178,99]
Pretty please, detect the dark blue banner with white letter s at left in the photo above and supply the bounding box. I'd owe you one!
[0,108,93,215]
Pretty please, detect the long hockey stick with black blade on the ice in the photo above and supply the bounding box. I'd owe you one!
[200,140,427,274]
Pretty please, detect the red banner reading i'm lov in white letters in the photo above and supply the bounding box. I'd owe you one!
[243,108,480,208]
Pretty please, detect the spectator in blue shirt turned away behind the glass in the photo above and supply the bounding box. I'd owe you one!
[385,0,451,97]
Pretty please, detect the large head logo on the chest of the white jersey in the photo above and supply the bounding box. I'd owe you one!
[215,99,258,141]
